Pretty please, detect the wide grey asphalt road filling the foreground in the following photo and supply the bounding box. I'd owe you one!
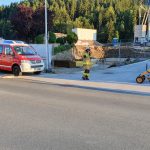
[0,79,150,150]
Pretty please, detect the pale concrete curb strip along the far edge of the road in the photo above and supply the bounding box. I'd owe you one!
[3,76,150,96]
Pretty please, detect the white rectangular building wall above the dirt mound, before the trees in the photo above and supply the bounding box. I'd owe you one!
[72,28,97,41]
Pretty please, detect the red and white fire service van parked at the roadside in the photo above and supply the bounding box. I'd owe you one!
[0,41,44,76]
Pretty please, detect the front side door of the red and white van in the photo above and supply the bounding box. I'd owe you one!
[1,46,14,71]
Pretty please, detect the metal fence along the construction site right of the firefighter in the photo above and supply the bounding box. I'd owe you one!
[100,42,150,65]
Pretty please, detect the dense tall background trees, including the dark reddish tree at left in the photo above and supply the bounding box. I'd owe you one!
[0,0,139,42]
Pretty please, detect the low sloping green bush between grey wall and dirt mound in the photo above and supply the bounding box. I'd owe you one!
[54,45,72,55]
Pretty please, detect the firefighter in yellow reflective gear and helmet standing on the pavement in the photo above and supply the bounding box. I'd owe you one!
[82,47,92,80]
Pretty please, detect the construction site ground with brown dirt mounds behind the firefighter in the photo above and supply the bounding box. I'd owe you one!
[53,34,150,68]
